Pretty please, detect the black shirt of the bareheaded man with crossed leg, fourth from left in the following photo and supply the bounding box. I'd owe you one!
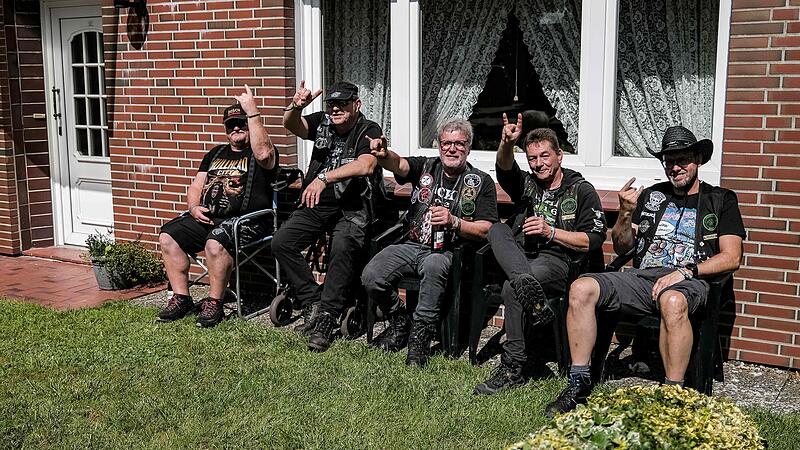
[495,161,606,253]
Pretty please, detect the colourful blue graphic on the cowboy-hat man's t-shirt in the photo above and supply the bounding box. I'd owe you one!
[640,202,697,269]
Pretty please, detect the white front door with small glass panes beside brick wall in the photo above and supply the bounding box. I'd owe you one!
[47,6,114,245]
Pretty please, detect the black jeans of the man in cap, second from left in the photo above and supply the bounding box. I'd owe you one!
[272,205,366,315]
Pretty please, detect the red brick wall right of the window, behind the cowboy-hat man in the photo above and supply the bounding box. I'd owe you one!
[722,0,800,368]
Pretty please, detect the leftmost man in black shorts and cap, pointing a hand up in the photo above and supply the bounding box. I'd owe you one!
[158,85,278,327]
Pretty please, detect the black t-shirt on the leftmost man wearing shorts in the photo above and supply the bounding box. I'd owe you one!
[198,145,278,219]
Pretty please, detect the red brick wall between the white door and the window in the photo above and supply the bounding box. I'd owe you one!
[103,0,296,246]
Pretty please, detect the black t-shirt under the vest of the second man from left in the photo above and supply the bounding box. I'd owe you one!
[303,111,383,209]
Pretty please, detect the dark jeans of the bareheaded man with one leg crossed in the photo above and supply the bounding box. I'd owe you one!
[487,223,569,365]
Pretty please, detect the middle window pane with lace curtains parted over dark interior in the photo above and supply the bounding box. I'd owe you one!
[420,0,581,151]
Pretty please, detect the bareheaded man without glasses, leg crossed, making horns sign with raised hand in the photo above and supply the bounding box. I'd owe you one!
[474,114,606,395]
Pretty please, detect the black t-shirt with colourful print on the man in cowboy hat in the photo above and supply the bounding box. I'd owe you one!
[631,191,746,269]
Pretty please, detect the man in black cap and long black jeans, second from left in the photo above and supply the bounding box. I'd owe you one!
[272,81,383,351]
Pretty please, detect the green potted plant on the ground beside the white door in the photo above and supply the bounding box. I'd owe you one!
[86,232,166,290]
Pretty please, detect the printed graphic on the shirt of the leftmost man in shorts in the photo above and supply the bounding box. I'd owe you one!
[201,151,250,218]
